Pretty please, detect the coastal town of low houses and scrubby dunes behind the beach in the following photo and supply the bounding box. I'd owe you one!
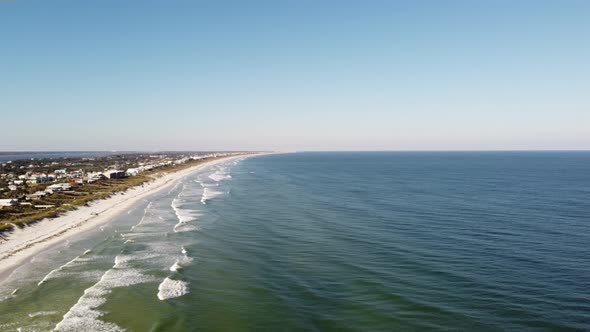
[0,152,252,232]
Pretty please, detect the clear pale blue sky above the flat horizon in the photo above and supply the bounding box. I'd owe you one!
[0,0,590,150]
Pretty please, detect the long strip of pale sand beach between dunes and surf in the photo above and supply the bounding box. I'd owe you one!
[0,154,259,284]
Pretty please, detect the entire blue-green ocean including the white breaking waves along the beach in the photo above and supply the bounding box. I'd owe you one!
[0,152,590,331]
